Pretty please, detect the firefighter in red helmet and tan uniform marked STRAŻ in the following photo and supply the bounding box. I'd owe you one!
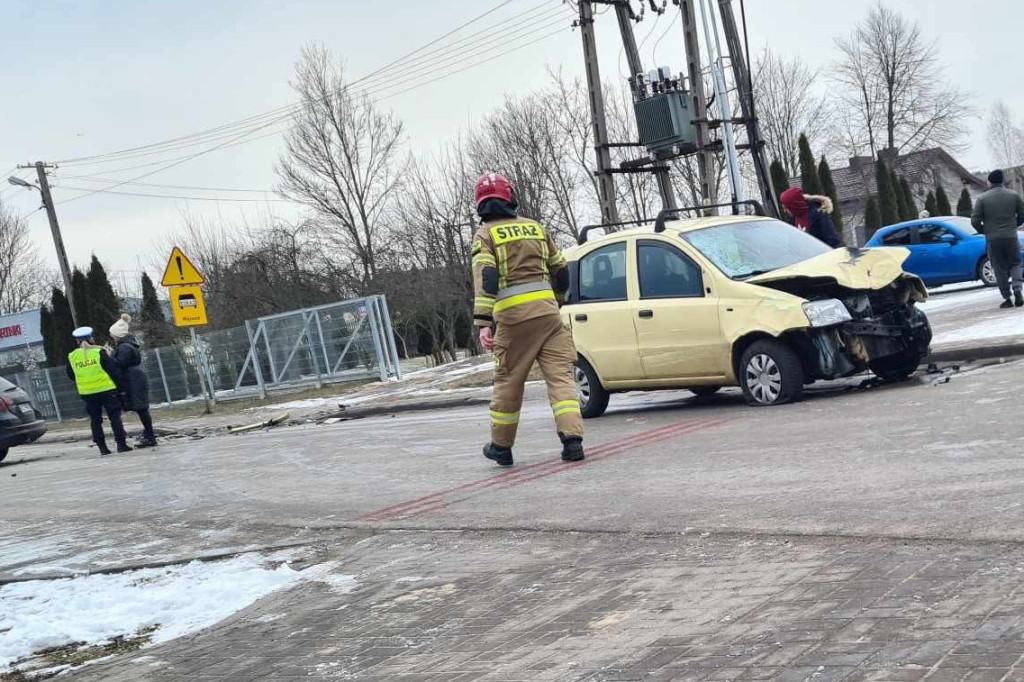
[472,173,584,467]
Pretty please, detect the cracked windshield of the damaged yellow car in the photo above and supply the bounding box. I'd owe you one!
[682,220,831,280]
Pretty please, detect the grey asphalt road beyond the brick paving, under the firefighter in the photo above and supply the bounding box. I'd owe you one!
[0,352,1024,561]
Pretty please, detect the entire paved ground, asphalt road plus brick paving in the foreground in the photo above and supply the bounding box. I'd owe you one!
[0,363,1024,682]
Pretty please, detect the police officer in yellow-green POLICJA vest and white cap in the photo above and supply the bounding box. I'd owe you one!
[68,327,132,456]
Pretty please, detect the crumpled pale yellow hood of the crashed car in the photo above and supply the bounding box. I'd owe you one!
[746,247,910,289]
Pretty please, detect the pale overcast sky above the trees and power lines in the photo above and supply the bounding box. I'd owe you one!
[0,0,1024,274]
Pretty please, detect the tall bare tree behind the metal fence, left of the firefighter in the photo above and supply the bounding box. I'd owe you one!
[276,47,406,288]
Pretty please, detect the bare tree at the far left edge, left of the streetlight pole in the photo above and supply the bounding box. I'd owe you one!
[0,197,50,314]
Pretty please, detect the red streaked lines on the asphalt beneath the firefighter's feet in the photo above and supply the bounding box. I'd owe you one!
[354,418,732,521]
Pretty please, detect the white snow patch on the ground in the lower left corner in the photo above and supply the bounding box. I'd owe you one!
[0,555,303,671]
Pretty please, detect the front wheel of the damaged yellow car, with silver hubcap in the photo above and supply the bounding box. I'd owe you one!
[739,339,804,408]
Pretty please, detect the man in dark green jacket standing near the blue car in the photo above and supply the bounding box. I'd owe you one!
[971,170,1024,308]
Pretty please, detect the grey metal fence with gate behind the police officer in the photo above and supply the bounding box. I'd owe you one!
[4,296,401,422]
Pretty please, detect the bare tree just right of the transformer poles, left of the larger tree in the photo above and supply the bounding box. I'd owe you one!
[754,48,830,177]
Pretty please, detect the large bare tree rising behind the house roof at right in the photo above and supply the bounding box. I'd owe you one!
[835,1,974,154]
